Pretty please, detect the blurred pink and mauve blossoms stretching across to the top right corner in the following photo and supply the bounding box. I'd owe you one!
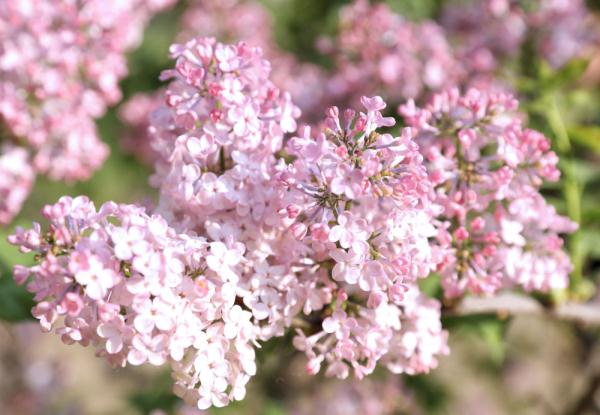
[315,0,598,110]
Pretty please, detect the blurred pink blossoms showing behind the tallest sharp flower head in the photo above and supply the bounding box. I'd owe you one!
[120,0,325,165]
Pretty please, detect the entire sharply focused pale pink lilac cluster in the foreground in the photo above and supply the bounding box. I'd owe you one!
[8,34,573,410]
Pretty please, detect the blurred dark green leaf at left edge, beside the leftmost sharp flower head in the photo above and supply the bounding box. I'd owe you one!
[0,262,34,322]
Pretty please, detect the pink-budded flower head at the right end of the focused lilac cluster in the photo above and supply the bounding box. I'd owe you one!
[400,89,575,297]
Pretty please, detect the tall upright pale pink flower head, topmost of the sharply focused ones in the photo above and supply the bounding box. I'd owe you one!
[152,38,299,223]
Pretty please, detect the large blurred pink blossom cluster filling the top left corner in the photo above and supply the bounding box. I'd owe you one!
[0,0,173,224]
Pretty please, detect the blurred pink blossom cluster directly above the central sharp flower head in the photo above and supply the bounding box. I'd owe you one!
[321,0,463,107]
